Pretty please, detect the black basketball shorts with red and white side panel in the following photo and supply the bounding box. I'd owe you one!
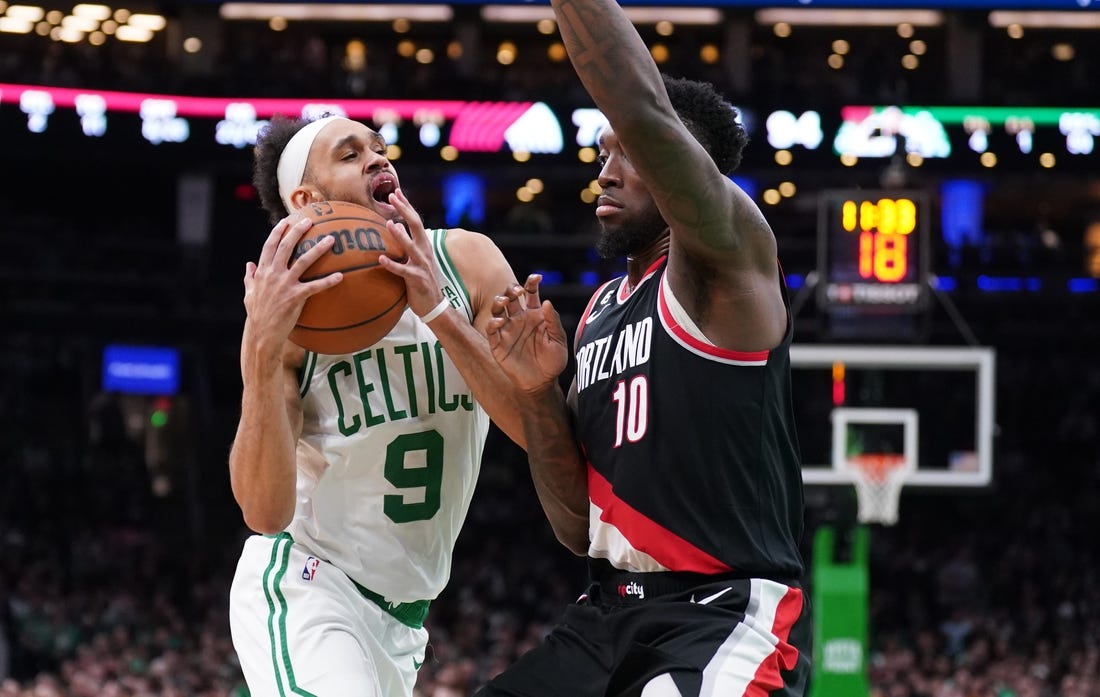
[477,573,812,697]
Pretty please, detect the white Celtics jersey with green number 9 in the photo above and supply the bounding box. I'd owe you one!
[287,230,488,602]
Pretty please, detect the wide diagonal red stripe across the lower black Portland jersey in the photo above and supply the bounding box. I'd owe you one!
[589,463,733,574]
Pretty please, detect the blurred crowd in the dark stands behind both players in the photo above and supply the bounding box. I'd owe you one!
[0,336,1100,697]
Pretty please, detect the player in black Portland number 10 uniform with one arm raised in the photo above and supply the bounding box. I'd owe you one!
[480,0,811,697]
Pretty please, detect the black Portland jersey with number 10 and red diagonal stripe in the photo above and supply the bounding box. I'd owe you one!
[576,258,803,578]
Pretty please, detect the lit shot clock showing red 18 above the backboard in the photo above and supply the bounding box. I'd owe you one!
[817,189,930,317]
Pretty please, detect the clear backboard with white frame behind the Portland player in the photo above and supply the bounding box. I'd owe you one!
[791,344,996,487]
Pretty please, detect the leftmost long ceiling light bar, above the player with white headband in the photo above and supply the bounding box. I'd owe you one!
[219,2,454,22]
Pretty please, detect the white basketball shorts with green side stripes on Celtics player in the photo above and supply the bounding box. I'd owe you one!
[229,533,428,697]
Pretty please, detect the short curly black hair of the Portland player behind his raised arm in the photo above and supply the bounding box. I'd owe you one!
[661,75,749,175]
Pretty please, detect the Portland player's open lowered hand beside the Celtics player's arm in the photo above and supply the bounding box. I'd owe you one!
[486,274,569,392]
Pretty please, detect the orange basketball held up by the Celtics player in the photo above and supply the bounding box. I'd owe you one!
[290,201,406,354]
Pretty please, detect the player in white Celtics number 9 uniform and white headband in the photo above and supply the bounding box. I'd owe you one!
[230,117,523,697]
